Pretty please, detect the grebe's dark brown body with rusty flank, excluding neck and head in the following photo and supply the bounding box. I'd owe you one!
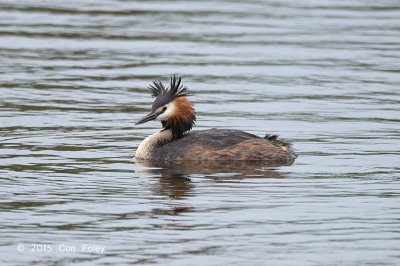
[151,128,297,165]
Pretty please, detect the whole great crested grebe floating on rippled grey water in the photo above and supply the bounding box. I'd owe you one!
[135,76,297,165]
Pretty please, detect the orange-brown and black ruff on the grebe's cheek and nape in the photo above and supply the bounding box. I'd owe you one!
[161,97,196,139]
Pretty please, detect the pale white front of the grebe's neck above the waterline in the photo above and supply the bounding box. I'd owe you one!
[135,129,172,160]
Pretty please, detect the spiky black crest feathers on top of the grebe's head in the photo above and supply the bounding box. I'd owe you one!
[149,75,191,109]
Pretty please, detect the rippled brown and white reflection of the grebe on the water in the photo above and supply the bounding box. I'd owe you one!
[136,160,285,230]
